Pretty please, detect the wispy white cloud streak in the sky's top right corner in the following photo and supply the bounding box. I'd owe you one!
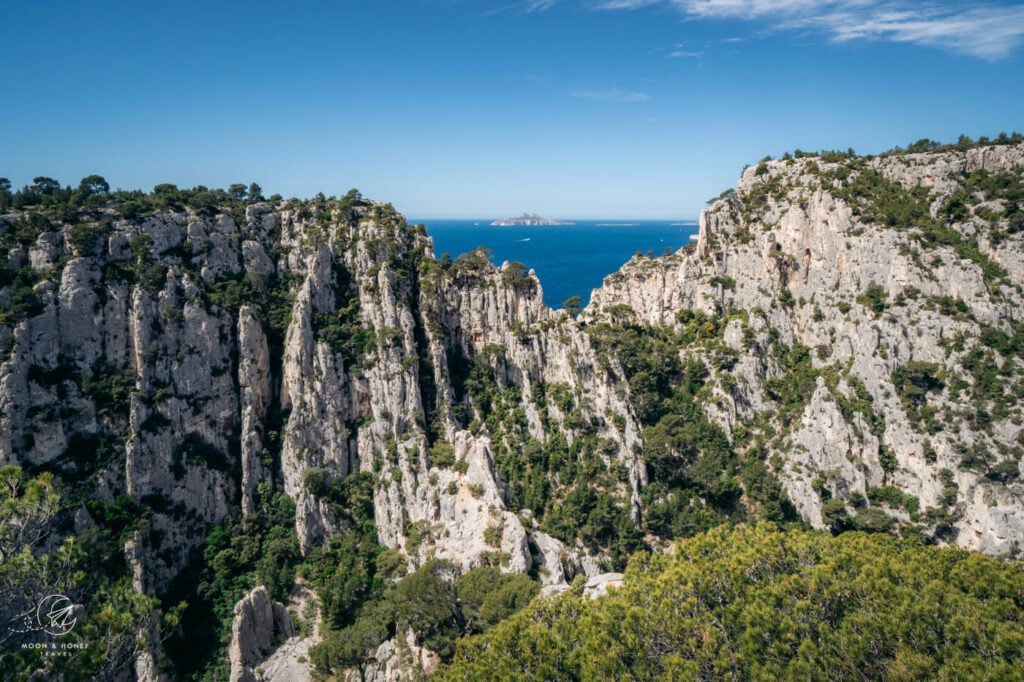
[589,0,1024,60]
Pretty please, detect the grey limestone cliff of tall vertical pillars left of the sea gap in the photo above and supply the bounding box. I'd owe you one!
[0,199,643,593]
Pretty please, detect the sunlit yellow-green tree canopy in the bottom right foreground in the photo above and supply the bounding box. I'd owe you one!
[439,524,1024,680]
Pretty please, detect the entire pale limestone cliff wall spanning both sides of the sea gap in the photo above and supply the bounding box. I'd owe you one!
[6,140,1024,666]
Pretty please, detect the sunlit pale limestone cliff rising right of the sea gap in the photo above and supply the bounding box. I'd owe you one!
[586,145,1024,554]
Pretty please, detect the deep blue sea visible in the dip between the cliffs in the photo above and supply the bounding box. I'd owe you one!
[410,219,697,308]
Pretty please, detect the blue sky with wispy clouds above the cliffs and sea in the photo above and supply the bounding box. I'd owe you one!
[0,0,1024,218]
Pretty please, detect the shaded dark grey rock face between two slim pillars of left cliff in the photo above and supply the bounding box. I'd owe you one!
[117,268,239,591]
